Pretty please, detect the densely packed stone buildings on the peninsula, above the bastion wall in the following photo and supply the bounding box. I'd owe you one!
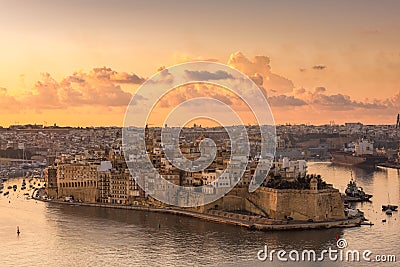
[45,124,307,204]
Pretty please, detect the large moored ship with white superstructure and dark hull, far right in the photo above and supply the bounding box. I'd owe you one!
[330,138,388,167]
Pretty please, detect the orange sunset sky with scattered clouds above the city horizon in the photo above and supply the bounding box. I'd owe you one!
[0,0,400,126]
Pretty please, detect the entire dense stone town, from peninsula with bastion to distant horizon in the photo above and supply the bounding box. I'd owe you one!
[0,123,398,225]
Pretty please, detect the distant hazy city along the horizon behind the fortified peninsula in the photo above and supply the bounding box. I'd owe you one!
[0,123,399,179]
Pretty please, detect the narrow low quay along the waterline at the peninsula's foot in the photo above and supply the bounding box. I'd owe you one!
[36,198,363,231]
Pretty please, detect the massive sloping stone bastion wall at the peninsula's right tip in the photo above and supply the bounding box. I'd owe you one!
[204,188,345,222]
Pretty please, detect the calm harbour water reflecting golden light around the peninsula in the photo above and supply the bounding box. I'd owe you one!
[0,163,400,266]
